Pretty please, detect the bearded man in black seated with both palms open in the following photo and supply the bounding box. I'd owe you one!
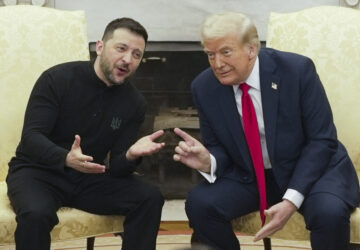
[7,18,164,250]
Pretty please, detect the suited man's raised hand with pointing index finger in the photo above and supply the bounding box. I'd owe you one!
[173,128,211,173]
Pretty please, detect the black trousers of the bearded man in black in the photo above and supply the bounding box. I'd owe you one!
[7,168,164,250]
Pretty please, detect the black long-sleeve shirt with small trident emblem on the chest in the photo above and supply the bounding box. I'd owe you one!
[9,62,146,176]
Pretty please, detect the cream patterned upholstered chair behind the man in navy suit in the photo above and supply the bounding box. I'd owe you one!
[234,6,360,249]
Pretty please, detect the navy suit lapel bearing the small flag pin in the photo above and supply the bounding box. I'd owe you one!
[259,49,281,160]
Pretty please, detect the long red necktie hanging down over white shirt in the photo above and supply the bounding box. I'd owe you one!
[240,83,268,226]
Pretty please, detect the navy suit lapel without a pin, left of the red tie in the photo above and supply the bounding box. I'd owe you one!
[218,86,251,166]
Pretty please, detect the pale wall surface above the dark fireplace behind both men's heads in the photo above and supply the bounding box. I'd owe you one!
[52,0,359,41]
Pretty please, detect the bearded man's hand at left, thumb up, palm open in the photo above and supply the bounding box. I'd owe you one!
[65,135,105,173]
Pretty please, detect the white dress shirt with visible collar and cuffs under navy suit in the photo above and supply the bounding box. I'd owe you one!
[199,58,304,208]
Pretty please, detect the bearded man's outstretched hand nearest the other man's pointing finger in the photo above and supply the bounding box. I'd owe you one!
[126,130,165,161]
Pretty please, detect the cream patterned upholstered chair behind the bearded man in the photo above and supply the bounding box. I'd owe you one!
[0,5,124,249]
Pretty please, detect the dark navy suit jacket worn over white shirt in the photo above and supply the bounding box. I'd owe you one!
[192,48,360,207]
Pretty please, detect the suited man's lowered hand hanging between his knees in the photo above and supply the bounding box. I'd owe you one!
[254,200,297,241]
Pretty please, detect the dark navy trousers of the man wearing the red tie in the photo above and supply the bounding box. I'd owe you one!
[186,170,351,250]
